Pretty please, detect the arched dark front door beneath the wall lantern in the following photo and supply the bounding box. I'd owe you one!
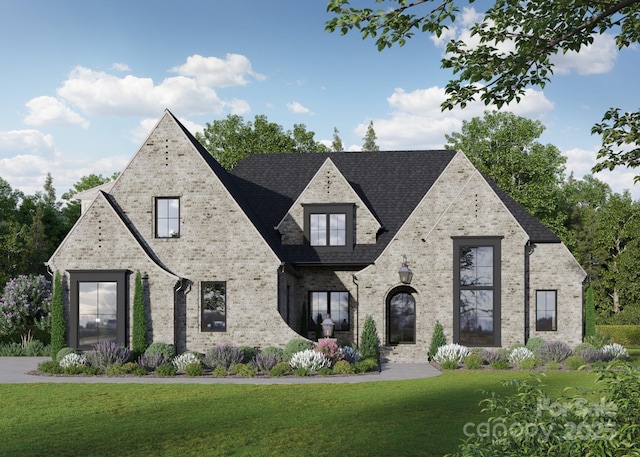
[387,287,416,344]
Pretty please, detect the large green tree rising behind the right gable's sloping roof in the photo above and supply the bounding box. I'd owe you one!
[445,111,566,237]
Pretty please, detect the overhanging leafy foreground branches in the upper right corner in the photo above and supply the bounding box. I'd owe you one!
[326,0,640,180]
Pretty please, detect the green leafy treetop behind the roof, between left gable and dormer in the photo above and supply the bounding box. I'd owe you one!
[196,114,329,170]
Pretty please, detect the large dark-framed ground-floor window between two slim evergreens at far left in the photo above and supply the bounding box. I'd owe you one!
[69,270,129,350]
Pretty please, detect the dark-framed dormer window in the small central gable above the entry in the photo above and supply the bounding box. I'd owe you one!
[304,204,355,249]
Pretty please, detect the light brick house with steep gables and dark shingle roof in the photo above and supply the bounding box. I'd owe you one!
[48,111,585,361]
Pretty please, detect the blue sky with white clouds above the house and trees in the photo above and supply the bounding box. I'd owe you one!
[0,0,640,199]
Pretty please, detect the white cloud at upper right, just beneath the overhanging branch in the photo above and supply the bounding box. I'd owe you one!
[551,34,618,75]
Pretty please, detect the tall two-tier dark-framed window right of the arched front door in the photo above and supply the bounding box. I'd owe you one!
[454,238,501,346]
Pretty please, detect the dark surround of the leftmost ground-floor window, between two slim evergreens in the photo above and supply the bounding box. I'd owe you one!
[67,270,131,348]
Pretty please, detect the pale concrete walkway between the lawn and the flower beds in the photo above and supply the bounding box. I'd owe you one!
[0,357,440,384]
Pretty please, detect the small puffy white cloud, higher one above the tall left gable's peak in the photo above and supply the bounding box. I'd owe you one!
[170,54,266,87]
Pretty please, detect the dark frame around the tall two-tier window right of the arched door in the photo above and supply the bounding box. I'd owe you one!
[452,236,503,347]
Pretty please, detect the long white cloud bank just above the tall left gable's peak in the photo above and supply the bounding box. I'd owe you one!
[57,66,225,116]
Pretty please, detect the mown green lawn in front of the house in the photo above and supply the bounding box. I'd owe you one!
[0,371,595,457]
